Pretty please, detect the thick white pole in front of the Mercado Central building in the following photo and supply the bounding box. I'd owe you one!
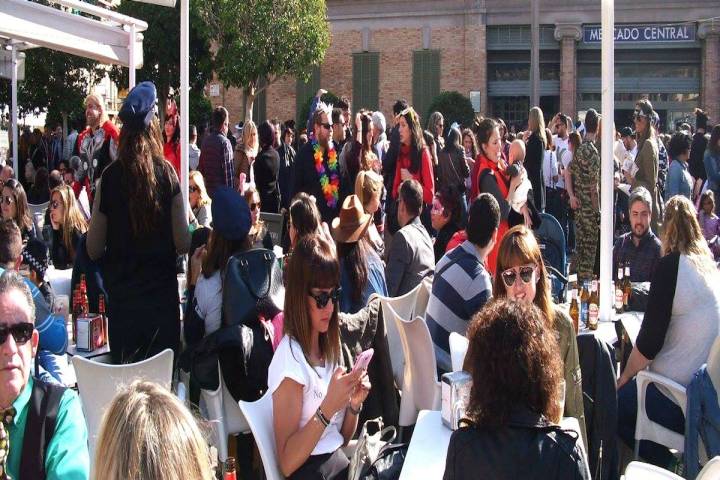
[599,0,615,321]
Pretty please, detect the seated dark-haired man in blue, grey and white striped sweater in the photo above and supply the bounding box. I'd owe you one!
[425,193,500,372]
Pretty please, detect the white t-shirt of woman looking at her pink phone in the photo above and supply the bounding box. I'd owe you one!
[268,335,345,455]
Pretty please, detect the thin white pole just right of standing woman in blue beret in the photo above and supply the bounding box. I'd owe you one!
[180,0,190,209]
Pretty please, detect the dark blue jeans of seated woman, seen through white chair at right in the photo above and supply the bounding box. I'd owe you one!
[618,379,685,468]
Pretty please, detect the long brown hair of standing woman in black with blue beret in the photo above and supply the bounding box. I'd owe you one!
[117,118,178,238]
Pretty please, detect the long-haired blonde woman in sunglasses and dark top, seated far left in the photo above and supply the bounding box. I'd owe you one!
[50,185,88,269]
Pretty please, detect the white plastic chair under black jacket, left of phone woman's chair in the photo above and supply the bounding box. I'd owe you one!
[200,363,250,462]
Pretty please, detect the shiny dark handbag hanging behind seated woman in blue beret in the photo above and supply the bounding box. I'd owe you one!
[223,248,285,326]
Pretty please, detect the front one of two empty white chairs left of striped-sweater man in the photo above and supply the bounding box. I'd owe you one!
[387,305,441,427]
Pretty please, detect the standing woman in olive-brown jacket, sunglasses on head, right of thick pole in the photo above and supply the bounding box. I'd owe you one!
[626,99,664,232]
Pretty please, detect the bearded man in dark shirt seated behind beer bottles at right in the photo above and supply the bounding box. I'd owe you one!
[613,187,662,282]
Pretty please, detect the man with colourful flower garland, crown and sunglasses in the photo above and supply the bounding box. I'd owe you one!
[293,102,340,224]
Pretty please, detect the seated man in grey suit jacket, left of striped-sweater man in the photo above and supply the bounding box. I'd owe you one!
[385,180,435,297]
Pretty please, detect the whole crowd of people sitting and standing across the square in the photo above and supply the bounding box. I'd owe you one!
[0,77,720,479]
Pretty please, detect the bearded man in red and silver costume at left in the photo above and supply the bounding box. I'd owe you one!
[72,94,120,200]
